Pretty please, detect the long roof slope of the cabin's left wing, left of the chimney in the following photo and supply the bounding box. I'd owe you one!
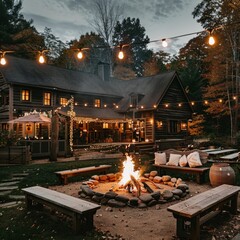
[0,56,122,96]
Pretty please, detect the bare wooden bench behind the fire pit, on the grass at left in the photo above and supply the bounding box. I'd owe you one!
[55,165,112,184]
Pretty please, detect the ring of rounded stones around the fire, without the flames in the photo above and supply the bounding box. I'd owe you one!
[79,171,189,208]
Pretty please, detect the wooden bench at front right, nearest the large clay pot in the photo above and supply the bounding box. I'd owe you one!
[167,184,240,240]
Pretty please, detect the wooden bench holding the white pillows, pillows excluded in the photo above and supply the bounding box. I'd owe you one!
[153,164,210,184]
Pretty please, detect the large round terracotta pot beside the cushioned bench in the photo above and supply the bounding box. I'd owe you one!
[209,163,235,187]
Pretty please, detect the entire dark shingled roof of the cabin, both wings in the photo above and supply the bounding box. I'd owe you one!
[0,56,191,112]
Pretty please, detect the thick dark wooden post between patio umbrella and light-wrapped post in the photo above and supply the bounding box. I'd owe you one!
[50,112,59,161]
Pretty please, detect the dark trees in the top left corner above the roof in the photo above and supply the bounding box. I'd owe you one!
[0,0,44,58]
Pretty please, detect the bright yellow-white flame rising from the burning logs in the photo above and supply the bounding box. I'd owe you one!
[119,156,140,186]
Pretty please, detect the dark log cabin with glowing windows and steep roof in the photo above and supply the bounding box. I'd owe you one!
[0,56,192,144]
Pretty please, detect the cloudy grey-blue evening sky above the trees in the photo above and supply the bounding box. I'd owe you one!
[21,0,203,54]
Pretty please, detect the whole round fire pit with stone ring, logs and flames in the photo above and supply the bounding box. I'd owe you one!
[79,156,188,208]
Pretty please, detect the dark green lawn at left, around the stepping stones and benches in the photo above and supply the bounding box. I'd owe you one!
[0,159,127,240]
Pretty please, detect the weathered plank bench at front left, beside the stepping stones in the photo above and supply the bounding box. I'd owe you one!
[22,186,101,233]
